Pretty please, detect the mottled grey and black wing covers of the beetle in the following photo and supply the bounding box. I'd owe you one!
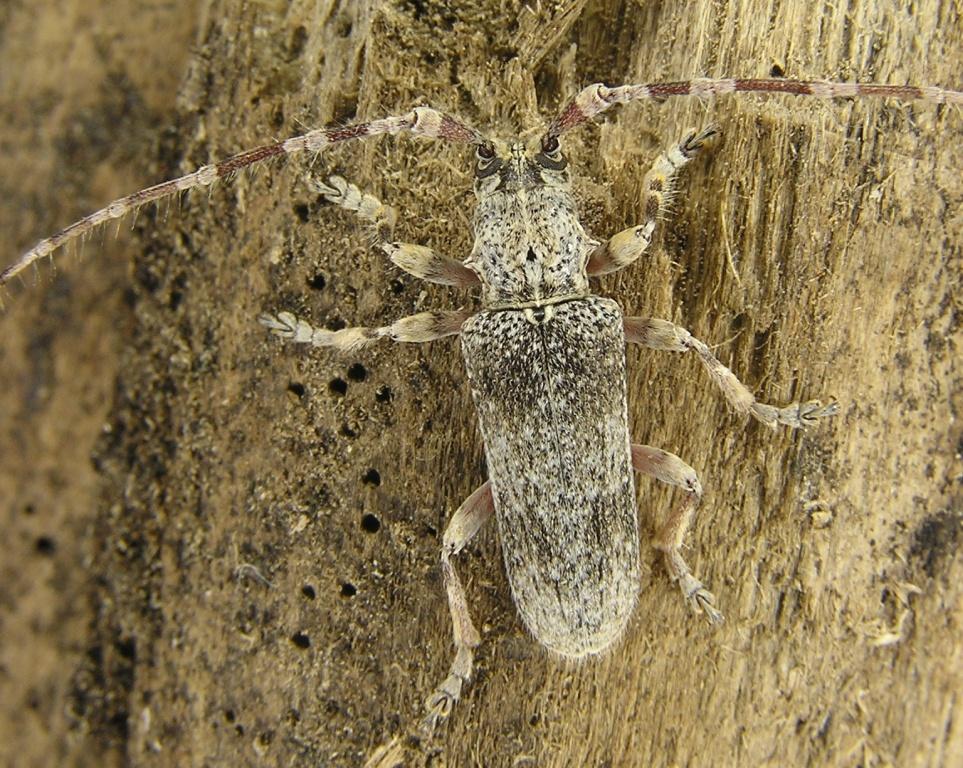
[462,297,639,657]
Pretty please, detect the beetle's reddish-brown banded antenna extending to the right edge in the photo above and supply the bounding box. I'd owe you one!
[543,78,963,141]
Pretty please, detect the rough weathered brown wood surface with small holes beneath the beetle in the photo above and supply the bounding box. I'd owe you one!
[0,0,963,766]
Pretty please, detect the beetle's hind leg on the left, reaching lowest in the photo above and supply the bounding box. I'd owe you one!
[422,481,495,736]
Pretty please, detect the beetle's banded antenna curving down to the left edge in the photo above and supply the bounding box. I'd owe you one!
[0,107,484,288]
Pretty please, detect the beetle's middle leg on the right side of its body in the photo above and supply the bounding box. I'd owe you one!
[624,317,839,429]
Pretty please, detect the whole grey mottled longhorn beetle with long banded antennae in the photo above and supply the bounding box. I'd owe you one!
[0,79,963,732]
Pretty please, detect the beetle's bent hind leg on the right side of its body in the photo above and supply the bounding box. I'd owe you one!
[632,444,723,624]
